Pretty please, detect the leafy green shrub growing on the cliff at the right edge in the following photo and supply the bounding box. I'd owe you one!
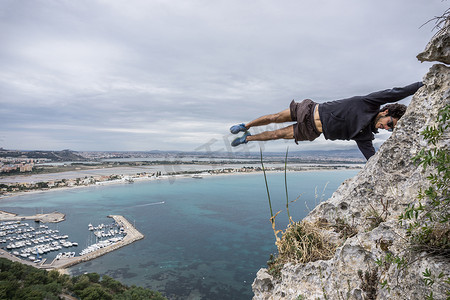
[399,105,450,255]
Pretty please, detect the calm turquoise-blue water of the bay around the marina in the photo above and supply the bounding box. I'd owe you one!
[0,170,357,299]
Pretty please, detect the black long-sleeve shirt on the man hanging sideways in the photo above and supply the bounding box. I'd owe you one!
[319,82,423,159]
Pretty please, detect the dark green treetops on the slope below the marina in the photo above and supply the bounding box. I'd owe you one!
[0,258,166,300]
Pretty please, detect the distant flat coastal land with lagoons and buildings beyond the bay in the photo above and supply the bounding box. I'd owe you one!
[0,149,363,197]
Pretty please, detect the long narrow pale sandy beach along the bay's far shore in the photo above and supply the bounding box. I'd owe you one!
[0,163,363,199]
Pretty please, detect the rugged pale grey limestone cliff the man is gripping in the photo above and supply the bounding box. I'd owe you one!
[252,29,450,300]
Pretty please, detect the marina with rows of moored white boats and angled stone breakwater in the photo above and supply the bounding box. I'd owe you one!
[0,211,144,270]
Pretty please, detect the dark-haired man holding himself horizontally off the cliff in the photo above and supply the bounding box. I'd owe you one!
[230,82,423,159]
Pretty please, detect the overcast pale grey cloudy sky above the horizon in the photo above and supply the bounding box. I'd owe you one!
[0,0,449,152]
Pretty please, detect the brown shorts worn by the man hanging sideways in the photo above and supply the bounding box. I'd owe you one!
[289,99,320,144]
